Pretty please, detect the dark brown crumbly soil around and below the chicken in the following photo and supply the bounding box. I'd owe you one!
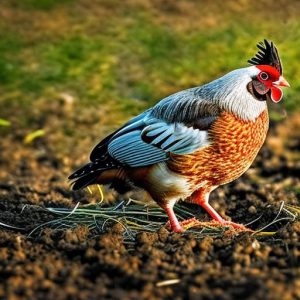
[0,110,300,300]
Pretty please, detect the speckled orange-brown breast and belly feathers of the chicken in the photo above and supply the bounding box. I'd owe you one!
[168,110,269,189]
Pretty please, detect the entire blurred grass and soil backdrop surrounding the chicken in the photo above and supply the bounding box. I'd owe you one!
[0,0,300,300]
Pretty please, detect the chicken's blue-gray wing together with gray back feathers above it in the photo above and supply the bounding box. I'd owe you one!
[107,86,220,167]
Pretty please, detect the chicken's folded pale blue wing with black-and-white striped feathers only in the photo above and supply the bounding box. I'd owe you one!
[108,119,208,167]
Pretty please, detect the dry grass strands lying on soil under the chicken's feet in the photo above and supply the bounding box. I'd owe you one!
[29,189,300,240]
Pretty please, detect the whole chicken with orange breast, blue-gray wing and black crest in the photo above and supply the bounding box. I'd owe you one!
[69,40,289,232]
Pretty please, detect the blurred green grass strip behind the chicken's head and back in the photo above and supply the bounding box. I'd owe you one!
[0,0,300,125]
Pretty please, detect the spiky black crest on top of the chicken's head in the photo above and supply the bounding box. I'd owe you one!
[248,40,282,75]
